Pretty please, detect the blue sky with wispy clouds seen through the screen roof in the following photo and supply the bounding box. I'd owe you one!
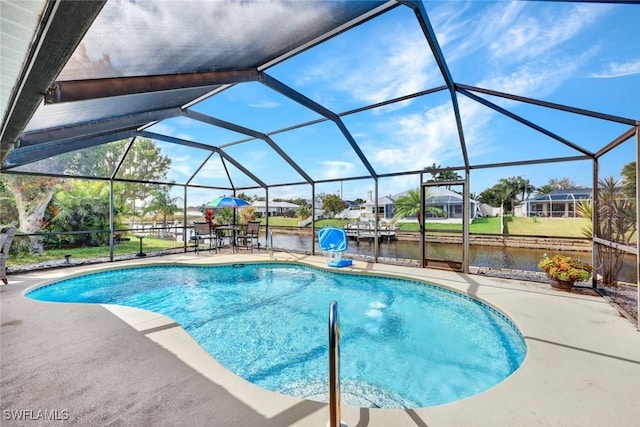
[140,1,640,204]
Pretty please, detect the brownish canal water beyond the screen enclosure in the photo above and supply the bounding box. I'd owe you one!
[273,234,636,282]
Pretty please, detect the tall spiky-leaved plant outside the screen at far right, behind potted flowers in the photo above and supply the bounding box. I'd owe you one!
[576,177,638,285]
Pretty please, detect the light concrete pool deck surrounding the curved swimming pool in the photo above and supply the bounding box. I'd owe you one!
[0,253,640,427]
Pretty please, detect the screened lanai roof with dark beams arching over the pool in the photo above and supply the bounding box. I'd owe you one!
[0,0,640,197]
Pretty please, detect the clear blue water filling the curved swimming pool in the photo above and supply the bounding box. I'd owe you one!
[27,263,526,408]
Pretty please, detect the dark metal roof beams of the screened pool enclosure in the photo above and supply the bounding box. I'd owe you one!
[0,0,640,300]
